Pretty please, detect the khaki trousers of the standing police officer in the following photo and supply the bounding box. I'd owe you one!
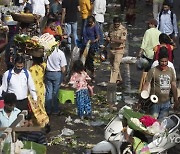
[109,49,124,83]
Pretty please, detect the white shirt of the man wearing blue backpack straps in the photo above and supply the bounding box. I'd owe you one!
[0,69,37,101]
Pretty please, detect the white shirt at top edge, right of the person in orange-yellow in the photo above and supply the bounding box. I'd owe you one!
[93,0,106,22]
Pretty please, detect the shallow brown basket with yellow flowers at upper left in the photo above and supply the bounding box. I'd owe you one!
[11,13,35,23]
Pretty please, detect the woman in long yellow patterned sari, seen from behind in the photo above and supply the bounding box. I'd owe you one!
[29,57,49,127]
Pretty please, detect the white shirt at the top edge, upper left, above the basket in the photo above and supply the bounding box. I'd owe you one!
[30,0,49,17]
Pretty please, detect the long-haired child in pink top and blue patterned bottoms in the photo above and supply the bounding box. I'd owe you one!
[69,60,92,119]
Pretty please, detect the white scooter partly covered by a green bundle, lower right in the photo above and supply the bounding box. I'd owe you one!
[91,106,180,154]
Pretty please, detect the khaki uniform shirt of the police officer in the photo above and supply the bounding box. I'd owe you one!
[109,24,127,50]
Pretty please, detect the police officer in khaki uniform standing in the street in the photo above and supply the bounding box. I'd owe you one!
[106,17,127,83]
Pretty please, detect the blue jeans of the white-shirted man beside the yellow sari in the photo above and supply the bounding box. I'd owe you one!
[45,71,62,114]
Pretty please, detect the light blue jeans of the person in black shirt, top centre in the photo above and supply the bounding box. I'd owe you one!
[65,22,78,49]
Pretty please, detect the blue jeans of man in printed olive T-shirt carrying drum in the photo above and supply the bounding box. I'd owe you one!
[150,101,171,120]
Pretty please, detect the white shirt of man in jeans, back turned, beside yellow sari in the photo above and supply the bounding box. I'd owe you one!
[46,47,67,72]
